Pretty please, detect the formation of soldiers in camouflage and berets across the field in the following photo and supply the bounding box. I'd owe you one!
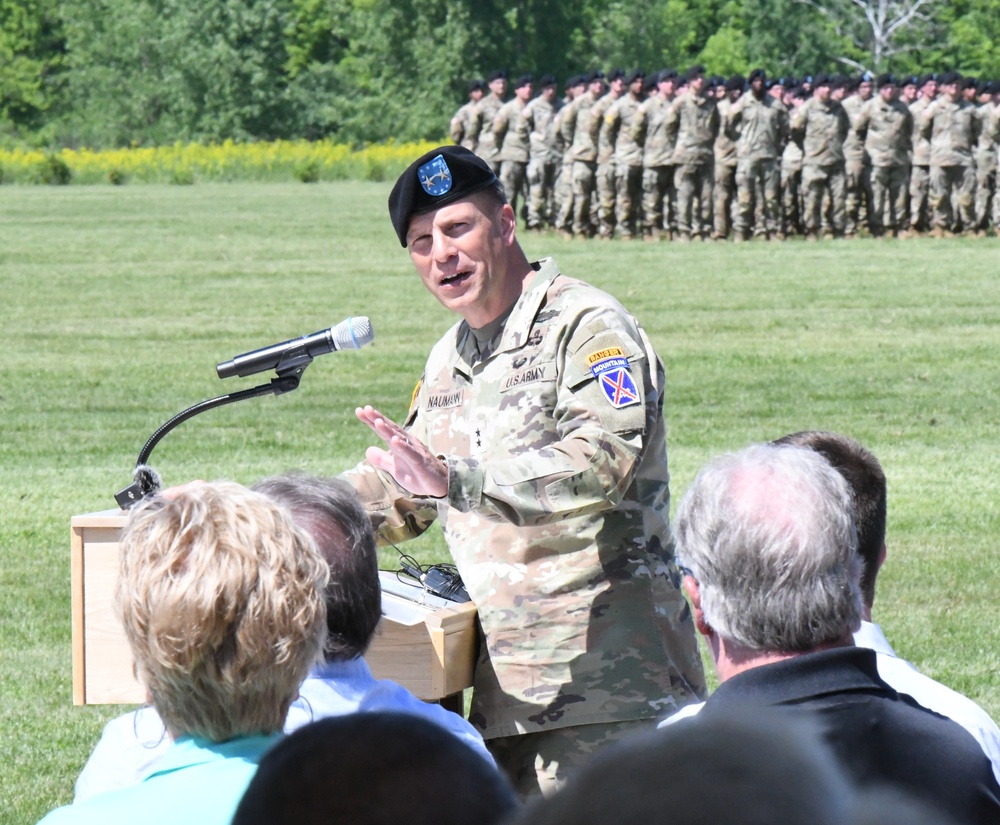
[451,66,1000,241]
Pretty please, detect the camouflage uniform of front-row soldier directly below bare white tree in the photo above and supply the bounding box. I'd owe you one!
[854,95,913,235]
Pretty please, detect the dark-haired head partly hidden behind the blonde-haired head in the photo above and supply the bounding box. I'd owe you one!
[253,473,382,661]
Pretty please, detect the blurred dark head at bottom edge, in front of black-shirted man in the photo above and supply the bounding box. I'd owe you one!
[516,707,853,825]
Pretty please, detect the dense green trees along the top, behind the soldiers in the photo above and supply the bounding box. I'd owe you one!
[0,0,1000,148]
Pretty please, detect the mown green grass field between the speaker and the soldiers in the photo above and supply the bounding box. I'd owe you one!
[0,183,1000,823]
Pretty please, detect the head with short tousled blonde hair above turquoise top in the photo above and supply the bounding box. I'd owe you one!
[115,482,327,742]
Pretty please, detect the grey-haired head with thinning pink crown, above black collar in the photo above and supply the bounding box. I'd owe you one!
[676,445,862,653]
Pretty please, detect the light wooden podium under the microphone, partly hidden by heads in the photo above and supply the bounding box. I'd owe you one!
[70,510,476,705]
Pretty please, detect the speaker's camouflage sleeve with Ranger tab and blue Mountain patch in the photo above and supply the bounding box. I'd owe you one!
[447,308,663,525]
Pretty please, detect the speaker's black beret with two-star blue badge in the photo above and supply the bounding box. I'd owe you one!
[389,146,497,247]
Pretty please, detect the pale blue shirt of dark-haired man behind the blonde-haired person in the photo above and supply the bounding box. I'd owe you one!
[74,658,496,802]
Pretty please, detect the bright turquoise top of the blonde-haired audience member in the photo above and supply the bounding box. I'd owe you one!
[40,734,281,825]
